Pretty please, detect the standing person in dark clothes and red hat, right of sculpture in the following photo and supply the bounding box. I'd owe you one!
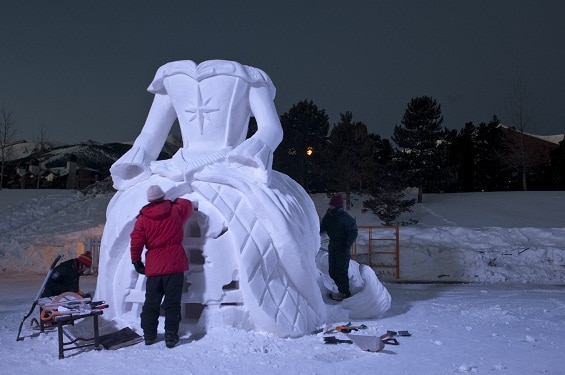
[320,194,357,301]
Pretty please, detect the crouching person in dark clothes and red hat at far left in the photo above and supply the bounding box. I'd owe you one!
[41,251,92,298]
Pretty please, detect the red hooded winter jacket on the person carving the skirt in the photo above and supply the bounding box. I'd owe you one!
[130,198,193,276]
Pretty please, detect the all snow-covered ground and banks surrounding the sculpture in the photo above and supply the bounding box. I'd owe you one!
[0,190,565,374]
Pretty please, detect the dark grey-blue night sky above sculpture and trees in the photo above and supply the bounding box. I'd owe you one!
[0,0,565,142]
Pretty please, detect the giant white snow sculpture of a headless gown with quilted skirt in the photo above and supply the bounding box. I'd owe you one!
[96,60,388,337]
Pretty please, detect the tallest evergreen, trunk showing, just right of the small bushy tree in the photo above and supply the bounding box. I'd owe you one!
[392,96,448,203]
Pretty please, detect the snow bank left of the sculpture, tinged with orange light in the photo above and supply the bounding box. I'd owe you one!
[0,189,112,273]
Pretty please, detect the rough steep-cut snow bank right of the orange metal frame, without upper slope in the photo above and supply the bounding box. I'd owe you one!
[400,227,565,284]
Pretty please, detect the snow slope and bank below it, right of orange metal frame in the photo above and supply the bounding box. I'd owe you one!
[392,191,565,284]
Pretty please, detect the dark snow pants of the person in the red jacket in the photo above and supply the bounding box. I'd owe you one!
[141,272,184,337]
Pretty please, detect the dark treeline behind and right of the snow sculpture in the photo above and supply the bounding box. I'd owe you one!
[273,96,565,222]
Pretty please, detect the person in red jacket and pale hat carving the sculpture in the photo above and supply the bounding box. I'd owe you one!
[130,185,193,348]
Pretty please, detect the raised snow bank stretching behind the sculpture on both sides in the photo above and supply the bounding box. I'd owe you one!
[0,189,565,284]
